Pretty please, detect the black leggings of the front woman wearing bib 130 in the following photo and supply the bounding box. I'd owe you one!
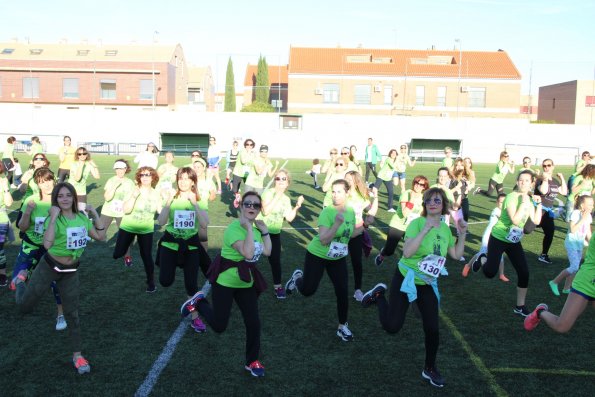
[377,268,440,367]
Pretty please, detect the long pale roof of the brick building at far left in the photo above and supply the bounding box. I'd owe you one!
[0,42,182,62]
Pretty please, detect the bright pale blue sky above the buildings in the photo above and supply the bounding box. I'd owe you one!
[0,0,595,94]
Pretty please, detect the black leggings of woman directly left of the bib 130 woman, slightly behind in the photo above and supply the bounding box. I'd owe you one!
[296,251,349,324]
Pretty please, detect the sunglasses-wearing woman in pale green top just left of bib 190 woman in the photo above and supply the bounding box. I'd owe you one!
[113,167,161,292]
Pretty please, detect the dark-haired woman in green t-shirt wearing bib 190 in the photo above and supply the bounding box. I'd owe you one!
[157,167,211,332]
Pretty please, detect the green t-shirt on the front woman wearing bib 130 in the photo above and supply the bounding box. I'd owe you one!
[399,217,455,285]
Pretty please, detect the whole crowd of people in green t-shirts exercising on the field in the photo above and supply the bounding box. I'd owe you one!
[0,136,595,387]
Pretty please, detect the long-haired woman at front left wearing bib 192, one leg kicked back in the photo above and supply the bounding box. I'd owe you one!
[16,183,105,374]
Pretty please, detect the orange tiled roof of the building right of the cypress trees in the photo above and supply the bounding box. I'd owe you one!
[289,47,521,79]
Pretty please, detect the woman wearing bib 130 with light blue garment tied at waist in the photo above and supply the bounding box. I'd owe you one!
[362,187,467,387]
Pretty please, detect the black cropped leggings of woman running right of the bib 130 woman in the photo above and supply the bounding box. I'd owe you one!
[483,236,529,288]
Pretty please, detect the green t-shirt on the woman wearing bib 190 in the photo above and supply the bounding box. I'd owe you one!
[161,198,200,251]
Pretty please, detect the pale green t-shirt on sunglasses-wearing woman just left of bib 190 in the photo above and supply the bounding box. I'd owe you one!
[120,189,161,234]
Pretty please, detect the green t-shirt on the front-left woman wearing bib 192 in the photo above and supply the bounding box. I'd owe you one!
[44,212,92,260]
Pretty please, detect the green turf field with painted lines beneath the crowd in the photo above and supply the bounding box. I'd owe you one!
[0,156,595,396]
